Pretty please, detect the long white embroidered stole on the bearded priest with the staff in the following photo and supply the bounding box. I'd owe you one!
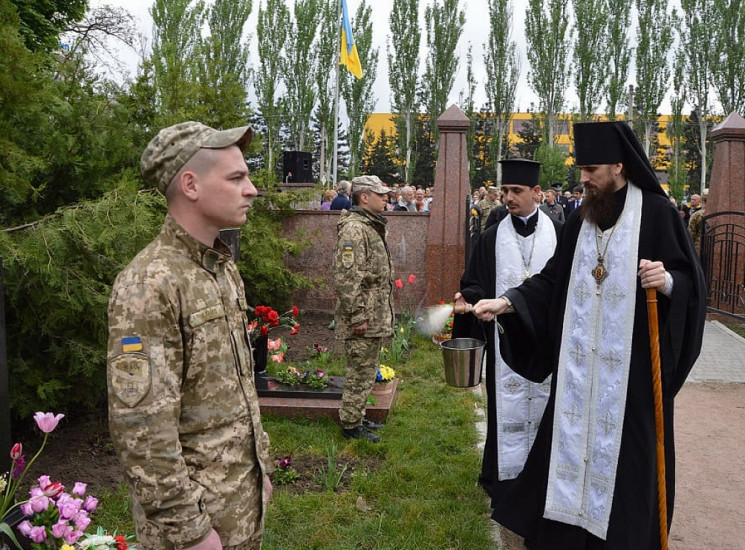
[544,184,642,540]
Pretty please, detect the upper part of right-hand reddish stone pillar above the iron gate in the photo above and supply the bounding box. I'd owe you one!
[706,113,745,214]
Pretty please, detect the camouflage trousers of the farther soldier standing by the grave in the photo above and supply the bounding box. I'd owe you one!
[339,336,383,429]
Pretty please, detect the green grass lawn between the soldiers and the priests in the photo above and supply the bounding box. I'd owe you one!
[94,337,494,550]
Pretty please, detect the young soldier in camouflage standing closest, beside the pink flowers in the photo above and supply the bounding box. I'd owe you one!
[107,122,271,550]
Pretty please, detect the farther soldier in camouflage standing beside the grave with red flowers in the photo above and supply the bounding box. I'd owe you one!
[333,176,393,443]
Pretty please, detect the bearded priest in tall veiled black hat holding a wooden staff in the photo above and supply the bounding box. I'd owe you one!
[474,122,706,550]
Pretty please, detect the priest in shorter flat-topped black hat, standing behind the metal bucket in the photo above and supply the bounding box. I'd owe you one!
[455,159,563,504]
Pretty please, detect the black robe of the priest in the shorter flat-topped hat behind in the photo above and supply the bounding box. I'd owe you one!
[453,214,563,506]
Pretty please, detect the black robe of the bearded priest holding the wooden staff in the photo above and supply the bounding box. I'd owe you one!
[492,187,706,550]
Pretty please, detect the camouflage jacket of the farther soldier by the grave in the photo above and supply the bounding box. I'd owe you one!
[333,206,393,338]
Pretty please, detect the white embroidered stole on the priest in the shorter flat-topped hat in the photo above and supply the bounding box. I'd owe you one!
[490,210,556,481]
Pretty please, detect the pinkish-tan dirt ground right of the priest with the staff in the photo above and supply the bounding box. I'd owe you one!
[498,383,745,550]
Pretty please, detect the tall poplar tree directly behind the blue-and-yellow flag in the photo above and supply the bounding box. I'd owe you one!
[341,0,378,177]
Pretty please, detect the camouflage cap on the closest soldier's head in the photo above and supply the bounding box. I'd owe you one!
[140,121,253,193]
